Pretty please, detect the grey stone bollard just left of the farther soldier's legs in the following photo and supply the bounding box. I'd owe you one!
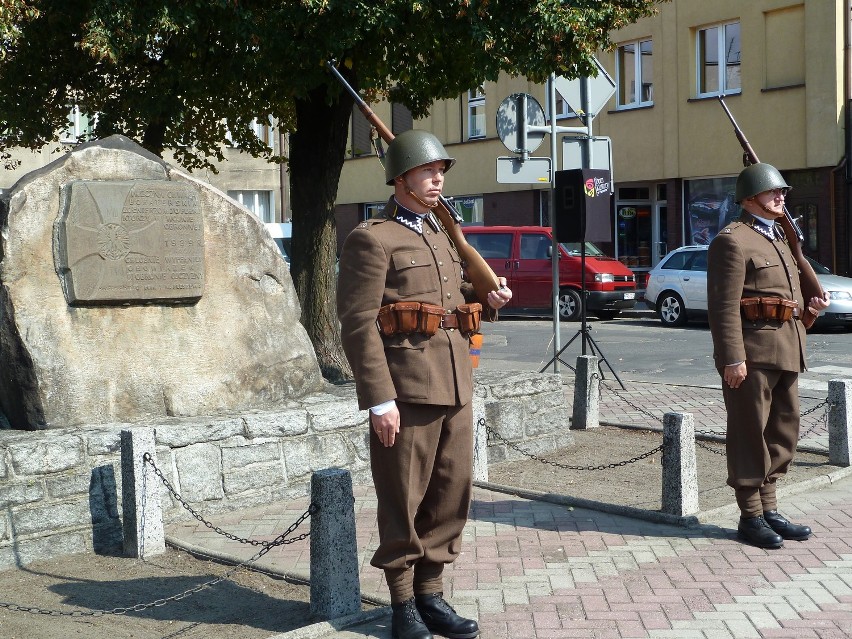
[662,413,698,517]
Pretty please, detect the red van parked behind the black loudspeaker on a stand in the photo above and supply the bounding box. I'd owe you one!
[462,226,636,321]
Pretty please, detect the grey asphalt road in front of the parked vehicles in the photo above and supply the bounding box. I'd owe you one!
[480,312,852,394]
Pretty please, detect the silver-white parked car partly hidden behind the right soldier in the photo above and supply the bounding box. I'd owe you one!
[645,246,852,328]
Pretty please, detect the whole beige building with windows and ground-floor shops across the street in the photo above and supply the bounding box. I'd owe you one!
[336,0,852,279]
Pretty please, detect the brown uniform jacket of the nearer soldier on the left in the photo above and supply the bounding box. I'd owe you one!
[337,197,475,409]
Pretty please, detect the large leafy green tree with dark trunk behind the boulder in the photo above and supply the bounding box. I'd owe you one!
[0,0,665,380]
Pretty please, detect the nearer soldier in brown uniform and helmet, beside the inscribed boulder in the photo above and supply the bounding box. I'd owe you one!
[337,131,511,639]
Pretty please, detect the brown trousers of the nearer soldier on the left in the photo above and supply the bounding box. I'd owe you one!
[370,401,473,603]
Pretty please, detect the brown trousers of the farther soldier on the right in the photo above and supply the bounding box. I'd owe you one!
[722,368,799,517]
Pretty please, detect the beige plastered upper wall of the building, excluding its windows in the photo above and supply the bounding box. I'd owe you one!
[338,0,844,198]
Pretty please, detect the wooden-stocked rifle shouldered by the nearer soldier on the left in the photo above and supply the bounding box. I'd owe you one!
[326,60,500,309]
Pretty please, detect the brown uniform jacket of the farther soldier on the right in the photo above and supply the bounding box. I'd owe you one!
[707,213,805,372]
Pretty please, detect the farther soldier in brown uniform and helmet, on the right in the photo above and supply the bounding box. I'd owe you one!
[707,164,828,548]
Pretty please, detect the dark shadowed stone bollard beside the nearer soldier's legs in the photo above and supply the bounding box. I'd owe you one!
[310,468,361,619]
